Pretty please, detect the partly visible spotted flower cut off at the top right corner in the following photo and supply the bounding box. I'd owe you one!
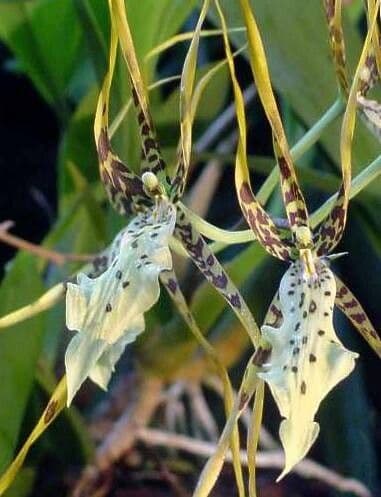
[323,0,381,139]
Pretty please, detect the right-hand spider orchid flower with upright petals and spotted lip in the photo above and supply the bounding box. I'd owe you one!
[216,0,381,478]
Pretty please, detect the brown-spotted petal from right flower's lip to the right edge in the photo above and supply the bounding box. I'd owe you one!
[335,275,381,357]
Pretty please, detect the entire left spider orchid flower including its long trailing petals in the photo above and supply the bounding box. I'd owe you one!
[0,0,260,488]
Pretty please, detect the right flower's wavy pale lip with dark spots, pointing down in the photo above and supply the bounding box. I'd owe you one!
[258,261,357,478]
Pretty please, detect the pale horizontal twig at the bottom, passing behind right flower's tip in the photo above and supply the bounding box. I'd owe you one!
[137,428,371,497]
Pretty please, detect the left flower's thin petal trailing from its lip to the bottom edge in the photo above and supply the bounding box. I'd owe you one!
[160,270,245,496]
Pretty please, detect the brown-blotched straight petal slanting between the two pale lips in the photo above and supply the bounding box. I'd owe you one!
[174,211,260,345]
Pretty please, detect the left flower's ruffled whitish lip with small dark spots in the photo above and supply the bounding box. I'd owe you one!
[65,203,175,405]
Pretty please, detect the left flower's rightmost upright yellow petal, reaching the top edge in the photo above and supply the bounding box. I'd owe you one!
[171,0,210,200]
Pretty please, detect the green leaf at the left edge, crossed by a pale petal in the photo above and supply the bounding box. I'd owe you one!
[0,253,45,472]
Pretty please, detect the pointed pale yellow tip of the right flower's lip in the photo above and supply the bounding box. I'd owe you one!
[276,419,320,482]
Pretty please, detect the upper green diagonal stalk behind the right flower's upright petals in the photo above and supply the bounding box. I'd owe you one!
[257,97,345,205]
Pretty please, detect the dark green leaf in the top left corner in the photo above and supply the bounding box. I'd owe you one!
[0,0,81,114]
